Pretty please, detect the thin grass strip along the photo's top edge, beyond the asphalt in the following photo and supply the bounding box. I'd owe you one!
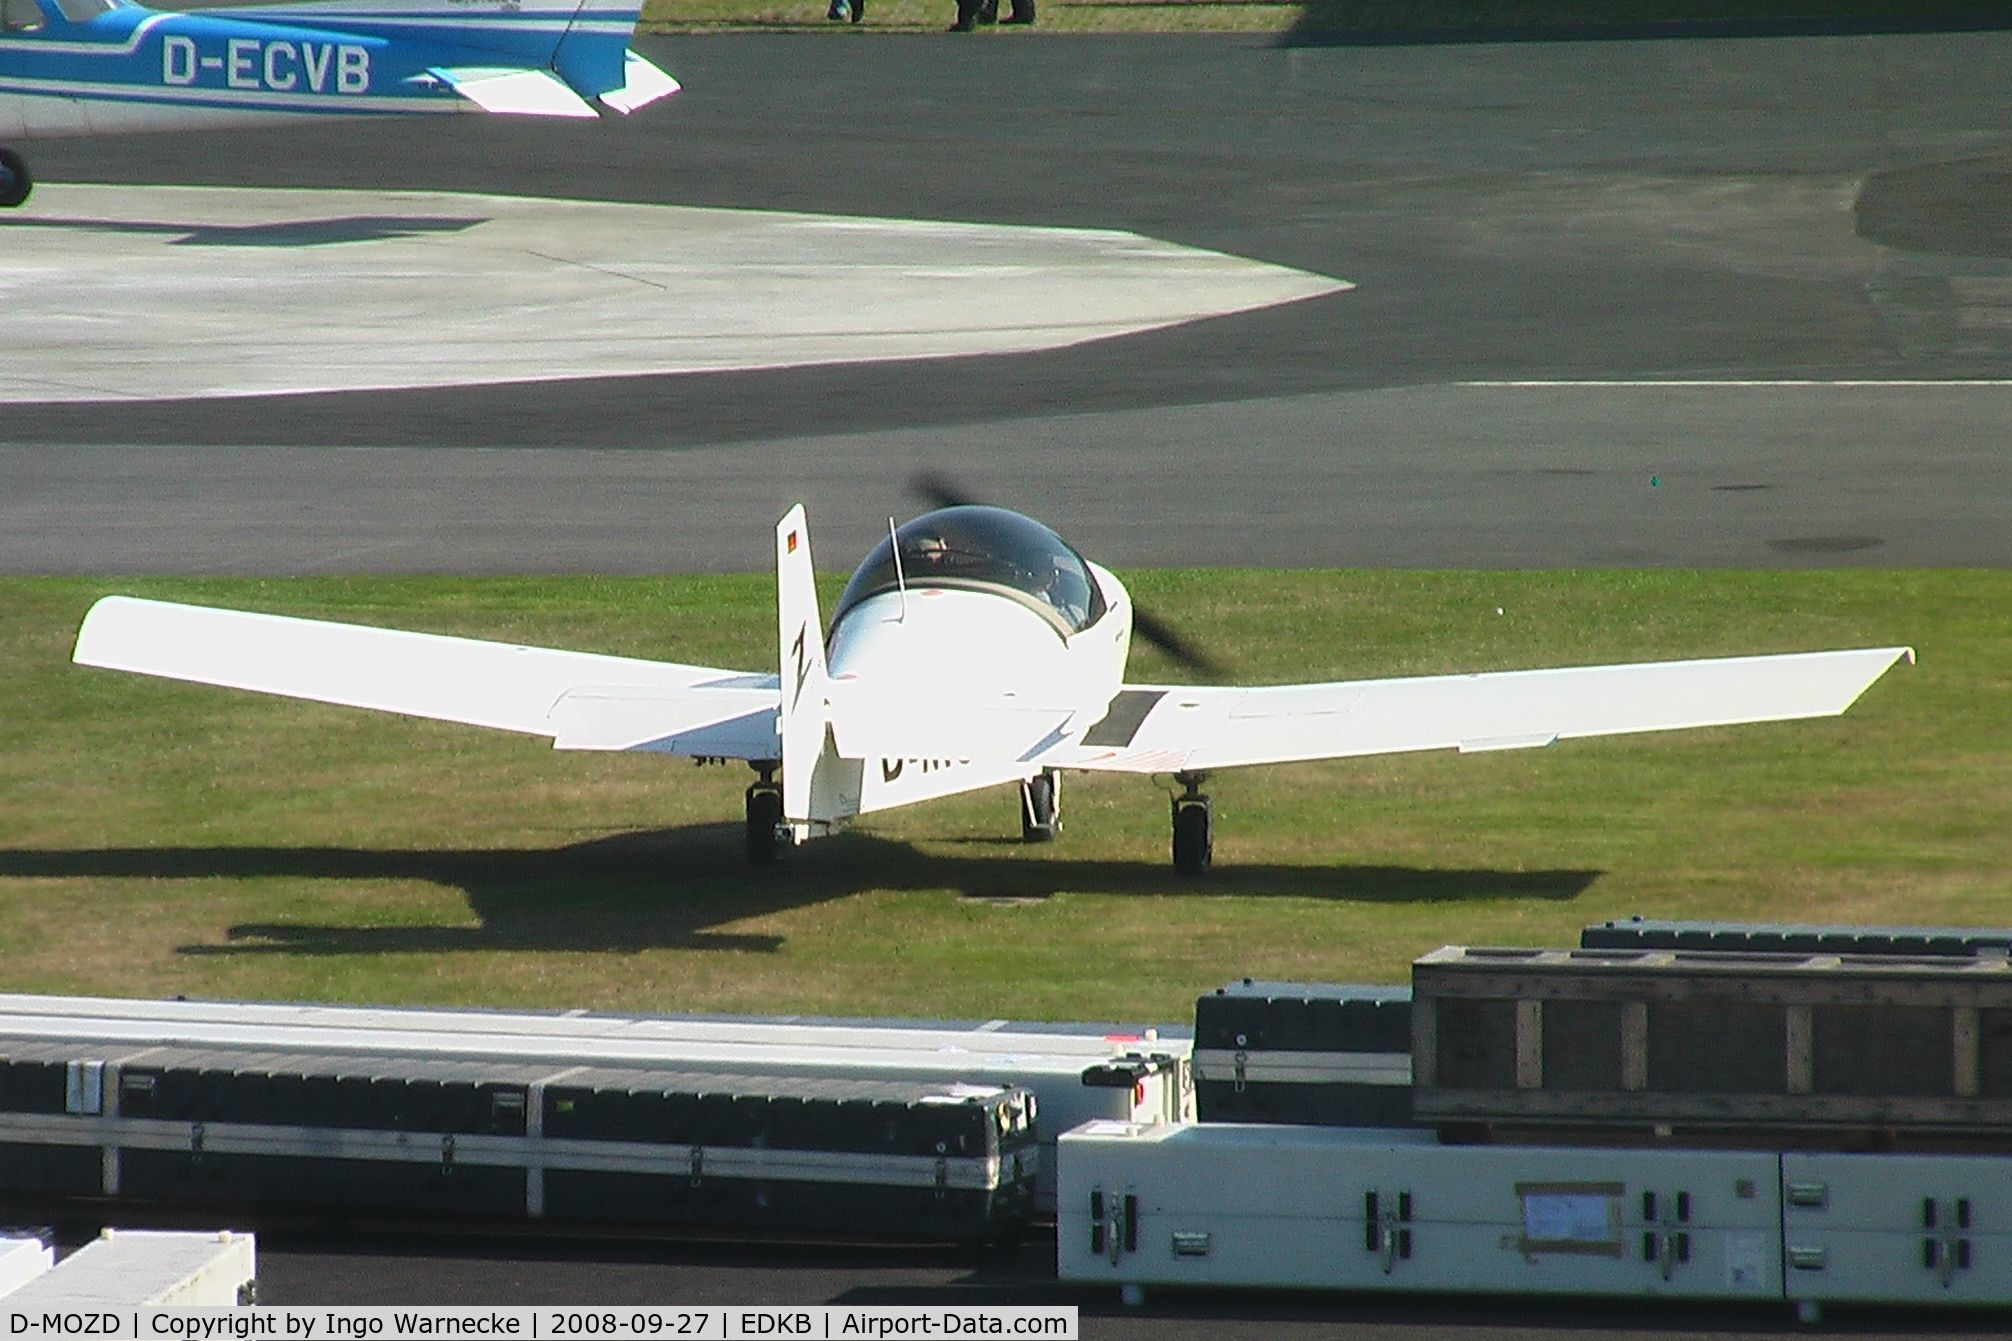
[644,0,2006,40]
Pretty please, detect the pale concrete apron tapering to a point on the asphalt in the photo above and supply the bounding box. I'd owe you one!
[0,185,1350,402]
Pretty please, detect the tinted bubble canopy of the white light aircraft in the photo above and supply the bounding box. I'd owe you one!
[831,505,1105,635]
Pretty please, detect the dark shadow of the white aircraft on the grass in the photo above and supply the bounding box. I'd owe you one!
[0,824,1600,955]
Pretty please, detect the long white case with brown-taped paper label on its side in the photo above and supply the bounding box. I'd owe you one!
[1056,1122,1781,1299]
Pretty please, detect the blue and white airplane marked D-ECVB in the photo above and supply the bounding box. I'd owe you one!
[0,0,678,207]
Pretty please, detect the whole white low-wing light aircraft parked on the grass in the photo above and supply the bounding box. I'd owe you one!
[74,505,1913,875]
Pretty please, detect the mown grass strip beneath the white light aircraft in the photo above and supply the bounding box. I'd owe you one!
[0,571,2012,1019]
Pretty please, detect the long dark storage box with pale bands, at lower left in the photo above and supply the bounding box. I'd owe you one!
[0,1037,1040,1240]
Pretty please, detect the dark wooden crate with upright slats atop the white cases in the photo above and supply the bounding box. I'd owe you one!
[1412,945,2012,1134]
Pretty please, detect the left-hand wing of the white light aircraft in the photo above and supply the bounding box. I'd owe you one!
[74,595,779,758]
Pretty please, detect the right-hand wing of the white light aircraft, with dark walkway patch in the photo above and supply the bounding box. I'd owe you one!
[1032,647,1913,772]
